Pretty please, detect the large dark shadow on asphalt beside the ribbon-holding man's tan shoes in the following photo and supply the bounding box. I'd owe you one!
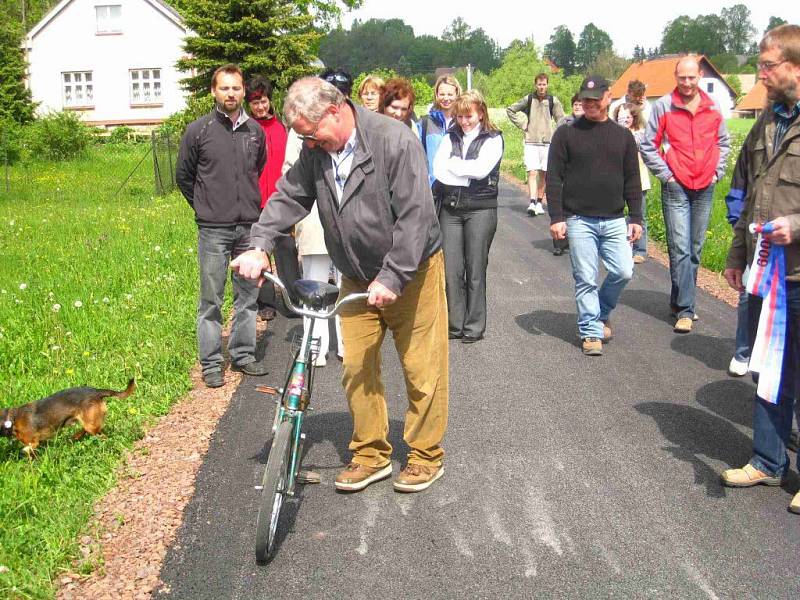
[636,404,752,498]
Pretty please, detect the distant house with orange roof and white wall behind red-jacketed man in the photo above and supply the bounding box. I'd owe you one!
[611,56,736,119]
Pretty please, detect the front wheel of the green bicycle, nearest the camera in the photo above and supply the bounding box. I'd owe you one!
[256,421,292,563]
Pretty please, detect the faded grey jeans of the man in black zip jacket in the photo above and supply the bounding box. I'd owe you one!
[197,225,258,375]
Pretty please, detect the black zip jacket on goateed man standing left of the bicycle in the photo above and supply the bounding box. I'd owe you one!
[175,108,267,227]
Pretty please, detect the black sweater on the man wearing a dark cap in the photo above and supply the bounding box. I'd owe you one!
[547,117,642,225]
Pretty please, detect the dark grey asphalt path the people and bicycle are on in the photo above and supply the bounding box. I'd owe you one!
[154,182,800,600]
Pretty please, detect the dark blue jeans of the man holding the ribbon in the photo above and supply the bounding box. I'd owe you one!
[747,282,800,476]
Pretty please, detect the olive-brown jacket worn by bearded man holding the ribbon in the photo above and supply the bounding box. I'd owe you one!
[726,109,800,282]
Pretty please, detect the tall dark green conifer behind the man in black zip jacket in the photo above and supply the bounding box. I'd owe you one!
[178,0,362,96]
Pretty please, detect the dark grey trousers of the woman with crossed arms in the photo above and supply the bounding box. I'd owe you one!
[439,206,497,338]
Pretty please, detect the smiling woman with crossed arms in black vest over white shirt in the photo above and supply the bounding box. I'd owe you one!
[433,90,503,344]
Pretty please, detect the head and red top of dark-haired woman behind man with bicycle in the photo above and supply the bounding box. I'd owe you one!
[245,75,287,208]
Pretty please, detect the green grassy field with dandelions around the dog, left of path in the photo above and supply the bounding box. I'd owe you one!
[0,145,197,598]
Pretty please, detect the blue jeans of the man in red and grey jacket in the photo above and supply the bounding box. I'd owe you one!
[661,181,714,318]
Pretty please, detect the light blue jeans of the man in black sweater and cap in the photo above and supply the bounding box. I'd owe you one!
[567,215,633,339]
